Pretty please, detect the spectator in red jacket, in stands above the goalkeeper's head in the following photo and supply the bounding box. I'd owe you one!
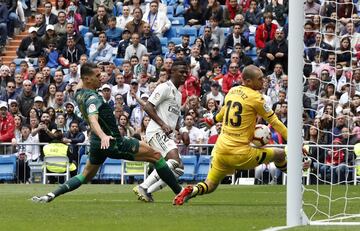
[255,12,278,49]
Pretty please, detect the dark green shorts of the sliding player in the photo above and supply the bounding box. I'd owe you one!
[89,137,140,165]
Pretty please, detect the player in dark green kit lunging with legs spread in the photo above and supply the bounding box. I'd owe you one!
[32,64,186,203]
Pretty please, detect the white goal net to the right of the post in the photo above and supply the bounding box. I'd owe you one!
[300,0,360,225]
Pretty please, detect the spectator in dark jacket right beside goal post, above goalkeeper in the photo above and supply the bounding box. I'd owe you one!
[260,29,288,73]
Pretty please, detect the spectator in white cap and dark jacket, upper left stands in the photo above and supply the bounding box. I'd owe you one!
[16,27,41,58]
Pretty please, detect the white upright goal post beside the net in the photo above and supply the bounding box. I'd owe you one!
[286,0,304,227]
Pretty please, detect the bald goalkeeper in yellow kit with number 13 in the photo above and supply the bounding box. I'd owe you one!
[174,65,310,205]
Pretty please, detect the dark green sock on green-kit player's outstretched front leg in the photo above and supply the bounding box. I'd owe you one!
[154,157,182,194]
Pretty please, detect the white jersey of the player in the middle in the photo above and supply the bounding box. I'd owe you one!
[146,80,181,141]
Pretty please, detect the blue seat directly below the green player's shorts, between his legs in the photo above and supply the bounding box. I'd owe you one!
[100,158,122,181]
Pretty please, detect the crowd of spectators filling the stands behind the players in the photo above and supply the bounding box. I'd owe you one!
[0,0,360,184]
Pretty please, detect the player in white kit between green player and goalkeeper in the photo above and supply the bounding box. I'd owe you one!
[133,60,189,202]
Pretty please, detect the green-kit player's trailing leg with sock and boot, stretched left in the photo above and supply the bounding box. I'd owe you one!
[31,160,100,203]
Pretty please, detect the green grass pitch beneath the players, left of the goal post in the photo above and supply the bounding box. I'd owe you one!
[0,184,360,231]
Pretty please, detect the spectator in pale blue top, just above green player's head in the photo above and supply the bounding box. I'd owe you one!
[89,32,113,63]
